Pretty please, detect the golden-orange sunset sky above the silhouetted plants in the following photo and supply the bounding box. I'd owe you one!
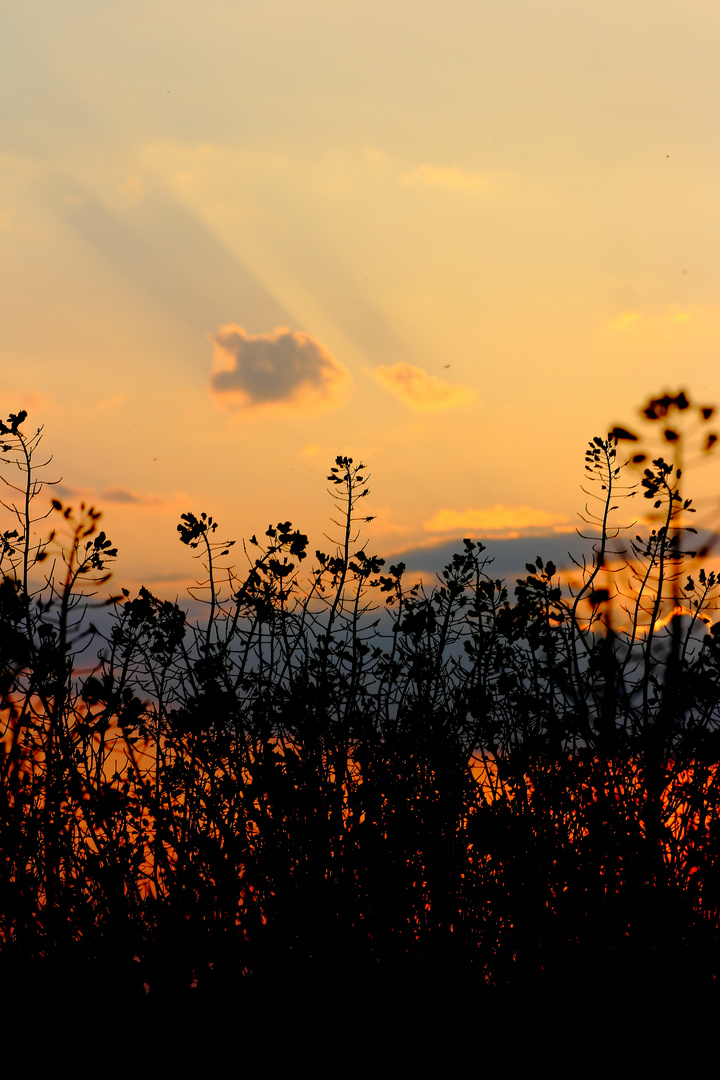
[0,0,720,596]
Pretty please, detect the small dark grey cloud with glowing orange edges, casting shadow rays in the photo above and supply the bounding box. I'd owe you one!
[210,324,350,408]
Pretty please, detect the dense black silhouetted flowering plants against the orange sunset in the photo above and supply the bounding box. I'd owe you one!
[0,395,720,999]
